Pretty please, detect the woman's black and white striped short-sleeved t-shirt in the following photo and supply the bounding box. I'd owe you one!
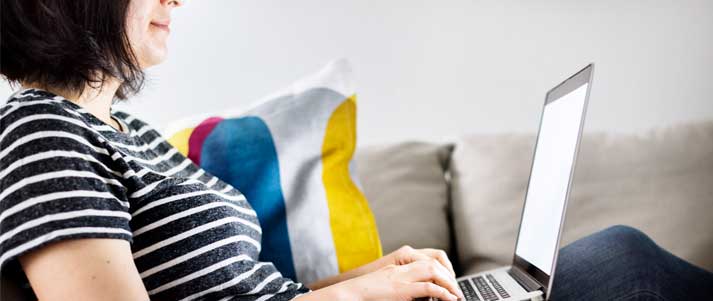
[0,89,309,300]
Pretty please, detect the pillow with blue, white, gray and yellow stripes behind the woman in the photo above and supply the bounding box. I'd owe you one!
[164,59,382,283]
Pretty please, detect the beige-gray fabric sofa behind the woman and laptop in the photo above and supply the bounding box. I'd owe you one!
[0,121,713,301]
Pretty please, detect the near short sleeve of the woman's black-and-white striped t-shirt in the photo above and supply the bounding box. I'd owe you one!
[0,101,132,269]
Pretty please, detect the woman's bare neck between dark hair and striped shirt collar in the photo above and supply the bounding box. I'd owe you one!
[22,79,121,125]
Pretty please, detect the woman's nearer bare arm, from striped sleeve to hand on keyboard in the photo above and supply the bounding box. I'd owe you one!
[20,238,462,301]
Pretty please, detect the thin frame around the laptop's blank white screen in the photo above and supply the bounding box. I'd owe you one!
[512,63,594,298]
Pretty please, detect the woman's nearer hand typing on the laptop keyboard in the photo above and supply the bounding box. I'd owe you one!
[327,259,464,301]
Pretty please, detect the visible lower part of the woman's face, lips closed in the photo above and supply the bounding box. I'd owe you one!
[126,0,184,69]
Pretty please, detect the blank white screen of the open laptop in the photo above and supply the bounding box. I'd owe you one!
[515,84,587,275]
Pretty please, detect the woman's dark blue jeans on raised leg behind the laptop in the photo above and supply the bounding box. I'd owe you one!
[550,226,713,301]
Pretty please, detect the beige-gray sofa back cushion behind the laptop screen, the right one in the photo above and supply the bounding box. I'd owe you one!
[451,122,713,272]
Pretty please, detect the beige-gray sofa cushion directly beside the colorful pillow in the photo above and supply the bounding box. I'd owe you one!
[355,142,452,254]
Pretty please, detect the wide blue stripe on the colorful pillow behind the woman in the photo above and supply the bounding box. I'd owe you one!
[201,116,296,279]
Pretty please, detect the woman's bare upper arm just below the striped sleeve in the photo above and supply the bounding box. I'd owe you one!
[20,238,149,301]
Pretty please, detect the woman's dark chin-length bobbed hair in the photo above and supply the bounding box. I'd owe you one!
[0,0,145,100]
